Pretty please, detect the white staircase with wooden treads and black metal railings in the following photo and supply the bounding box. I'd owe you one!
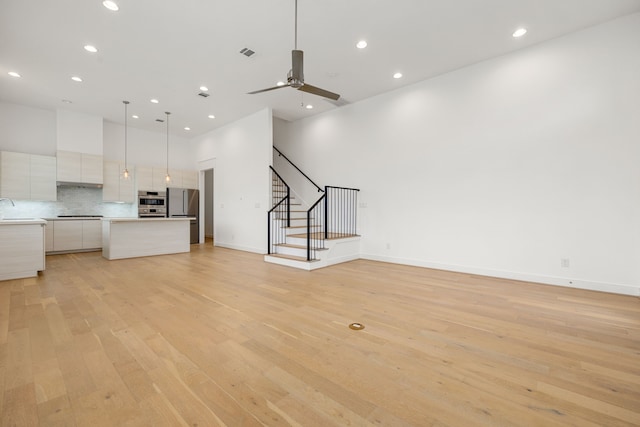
[264,147,360,270]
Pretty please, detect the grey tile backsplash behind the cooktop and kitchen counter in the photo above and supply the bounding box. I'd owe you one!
[0,187,138,218]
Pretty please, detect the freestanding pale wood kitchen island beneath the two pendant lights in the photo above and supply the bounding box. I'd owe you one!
[102,218,191,260]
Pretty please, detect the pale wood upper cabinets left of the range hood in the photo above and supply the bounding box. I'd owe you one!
[0,151,57,201]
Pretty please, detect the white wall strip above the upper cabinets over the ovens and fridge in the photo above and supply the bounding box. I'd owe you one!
[103,122,196,170]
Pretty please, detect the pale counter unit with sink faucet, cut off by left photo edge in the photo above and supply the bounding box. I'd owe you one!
[0,218,47,280]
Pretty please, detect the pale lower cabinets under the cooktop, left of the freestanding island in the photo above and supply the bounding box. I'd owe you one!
[46,219,102,252]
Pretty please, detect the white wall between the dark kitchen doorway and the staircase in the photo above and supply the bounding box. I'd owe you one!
[192,109,273,253]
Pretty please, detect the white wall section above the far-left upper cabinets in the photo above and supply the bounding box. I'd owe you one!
[0,102,56,156]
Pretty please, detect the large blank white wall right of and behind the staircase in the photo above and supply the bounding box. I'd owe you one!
[274,14,640,295]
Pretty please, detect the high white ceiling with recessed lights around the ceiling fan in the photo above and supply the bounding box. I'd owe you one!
[0,0,640,138]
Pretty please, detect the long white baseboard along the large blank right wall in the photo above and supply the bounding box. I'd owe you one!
[360,254,640,297]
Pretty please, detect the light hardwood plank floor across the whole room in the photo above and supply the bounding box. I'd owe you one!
[0,245,640,427]
